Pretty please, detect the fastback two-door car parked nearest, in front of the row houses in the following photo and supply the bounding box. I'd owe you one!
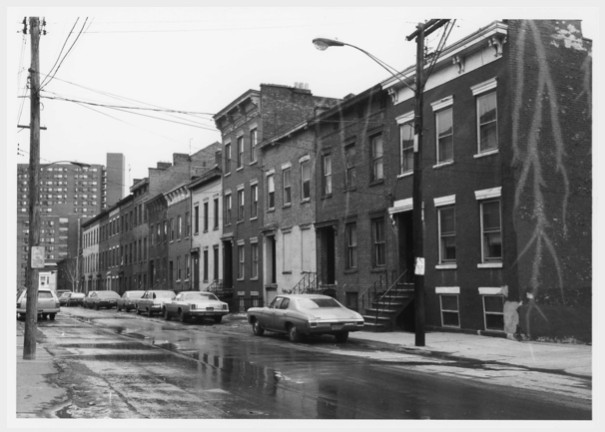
[246,294,364,342]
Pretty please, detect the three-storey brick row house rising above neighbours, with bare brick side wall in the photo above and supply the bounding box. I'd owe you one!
[214,84,336,310]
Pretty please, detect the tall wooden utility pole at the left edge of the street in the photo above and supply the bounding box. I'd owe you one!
[23,17,40,360]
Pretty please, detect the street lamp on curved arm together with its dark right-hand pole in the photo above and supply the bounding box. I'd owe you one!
[313,19,449,346]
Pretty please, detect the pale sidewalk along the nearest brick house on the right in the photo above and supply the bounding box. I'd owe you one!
[349,331,592,378]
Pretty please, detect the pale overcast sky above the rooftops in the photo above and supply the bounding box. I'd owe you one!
[6,1,595,187]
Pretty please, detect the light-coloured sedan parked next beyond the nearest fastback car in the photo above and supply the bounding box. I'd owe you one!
[162,291,229,324]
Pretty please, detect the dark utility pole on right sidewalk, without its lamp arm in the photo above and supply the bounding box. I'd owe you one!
[406,19,449,346]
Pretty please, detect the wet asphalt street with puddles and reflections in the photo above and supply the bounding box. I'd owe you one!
[18,308,591,420]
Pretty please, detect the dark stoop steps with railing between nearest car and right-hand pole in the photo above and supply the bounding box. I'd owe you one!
[363,273,414,332]
